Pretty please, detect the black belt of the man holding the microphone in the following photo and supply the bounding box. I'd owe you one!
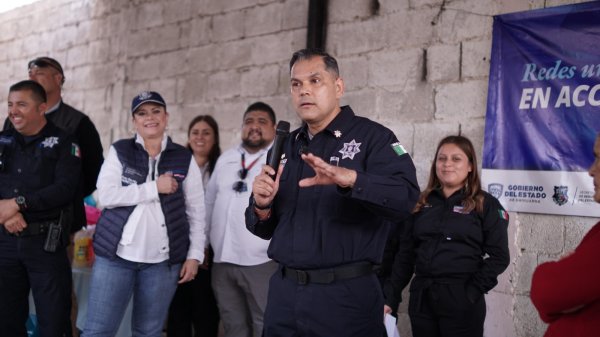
[281,262,373,285]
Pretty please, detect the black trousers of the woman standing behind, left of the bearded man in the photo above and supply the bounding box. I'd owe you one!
[167,269,219,337]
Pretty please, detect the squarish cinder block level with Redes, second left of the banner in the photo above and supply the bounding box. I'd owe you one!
[427,44,460,83]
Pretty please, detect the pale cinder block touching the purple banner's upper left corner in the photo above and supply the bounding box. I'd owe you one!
[434,9,492,44]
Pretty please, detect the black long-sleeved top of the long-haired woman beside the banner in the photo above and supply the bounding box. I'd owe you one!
[384,190,510,308]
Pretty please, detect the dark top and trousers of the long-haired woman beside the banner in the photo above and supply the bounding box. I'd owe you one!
[384,190,510,337]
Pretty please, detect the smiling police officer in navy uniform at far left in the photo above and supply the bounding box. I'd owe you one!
[0,80,81,337]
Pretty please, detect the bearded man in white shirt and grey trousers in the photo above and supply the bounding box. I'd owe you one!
[205,102,277,337]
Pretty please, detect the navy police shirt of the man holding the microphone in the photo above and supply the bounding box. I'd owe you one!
[246,106,419,269]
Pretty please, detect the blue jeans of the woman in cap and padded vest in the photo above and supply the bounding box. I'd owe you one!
[82,256,181,337]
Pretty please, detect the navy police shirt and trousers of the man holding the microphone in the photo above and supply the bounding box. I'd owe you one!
[246,106,419,337]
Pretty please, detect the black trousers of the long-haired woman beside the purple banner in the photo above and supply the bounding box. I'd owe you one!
[408,283,486,337]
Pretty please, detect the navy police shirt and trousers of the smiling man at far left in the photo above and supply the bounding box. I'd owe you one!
[0,122,81,337]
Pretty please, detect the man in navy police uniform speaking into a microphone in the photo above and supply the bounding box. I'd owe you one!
[246,49,419,337]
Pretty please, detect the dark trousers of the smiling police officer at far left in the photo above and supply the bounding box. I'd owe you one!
[0,231,72,337]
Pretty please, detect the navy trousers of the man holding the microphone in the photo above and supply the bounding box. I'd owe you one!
[263,268,385,337]
